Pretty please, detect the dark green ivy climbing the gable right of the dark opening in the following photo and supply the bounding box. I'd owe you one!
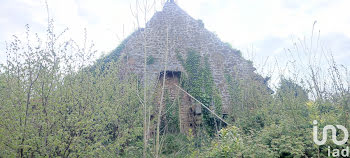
[177,51,222,135]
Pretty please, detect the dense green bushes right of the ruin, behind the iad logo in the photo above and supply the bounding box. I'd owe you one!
[203,73,347,157]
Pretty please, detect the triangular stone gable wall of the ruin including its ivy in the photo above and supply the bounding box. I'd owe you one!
[102,2,267,134]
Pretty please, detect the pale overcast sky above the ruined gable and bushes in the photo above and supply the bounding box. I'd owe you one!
[0,0,350,76]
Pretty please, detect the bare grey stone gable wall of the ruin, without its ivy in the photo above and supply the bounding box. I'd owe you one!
[101,0,267,133]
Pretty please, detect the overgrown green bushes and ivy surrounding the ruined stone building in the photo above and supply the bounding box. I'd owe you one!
[0,1,350,157]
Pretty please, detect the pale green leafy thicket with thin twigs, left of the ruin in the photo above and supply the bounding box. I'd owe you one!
[0,23,142,157]
